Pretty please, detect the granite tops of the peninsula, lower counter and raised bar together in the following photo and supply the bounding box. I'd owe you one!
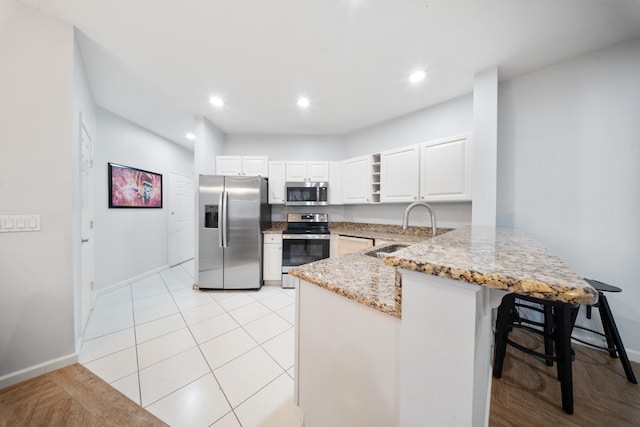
[289,227,598,318]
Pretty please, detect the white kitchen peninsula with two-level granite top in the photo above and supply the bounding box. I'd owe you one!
[290,227,597,427]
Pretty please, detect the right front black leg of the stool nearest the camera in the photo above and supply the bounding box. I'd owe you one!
[554,305,573,414]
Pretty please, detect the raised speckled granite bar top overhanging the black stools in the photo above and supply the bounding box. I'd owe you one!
[384,227,598,304]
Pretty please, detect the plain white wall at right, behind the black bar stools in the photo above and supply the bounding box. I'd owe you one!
[498,39,640,361]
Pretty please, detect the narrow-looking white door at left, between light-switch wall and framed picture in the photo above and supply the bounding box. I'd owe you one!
[79,115,95,333]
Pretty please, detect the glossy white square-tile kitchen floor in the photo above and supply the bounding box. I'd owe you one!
[80,261,302,427]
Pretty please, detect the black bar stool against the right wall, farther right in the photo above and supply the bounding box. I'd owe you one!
[573,279,638,384]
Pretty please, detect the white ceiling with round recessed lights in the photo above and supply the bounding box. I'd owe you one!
[20,0,640,144]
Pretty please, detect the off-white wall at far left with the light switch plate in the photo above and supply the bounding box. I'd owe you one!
[0,1,76,388]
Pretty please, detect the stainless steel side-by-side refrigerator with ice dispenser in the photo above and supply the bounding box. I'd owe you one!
[197,175,271,289]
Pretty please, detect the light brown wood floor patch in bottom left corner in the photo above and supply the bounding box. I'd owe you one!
[0,364,166,427]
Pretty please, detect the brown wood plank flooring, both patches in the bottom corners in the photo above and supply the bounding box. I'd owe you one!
[0,338,640,427]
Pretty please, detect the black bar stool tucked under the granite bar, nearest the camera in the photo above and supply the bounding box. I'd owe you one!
[493,294,578,414]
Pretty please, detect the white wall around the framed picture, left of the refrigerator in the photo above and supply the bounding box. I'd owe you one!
[94,108,194,290]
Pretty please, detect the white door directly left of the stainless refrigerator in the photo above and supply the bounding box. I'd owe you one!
[169,172,195,267]
